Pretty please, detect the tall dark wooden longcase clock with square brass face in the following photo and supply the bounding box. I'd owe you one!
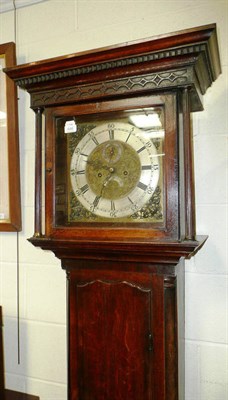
[6,24,221,400]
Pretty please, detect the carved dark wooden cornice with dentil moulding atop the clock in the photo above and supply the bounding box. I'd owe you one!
[5,24,221,111]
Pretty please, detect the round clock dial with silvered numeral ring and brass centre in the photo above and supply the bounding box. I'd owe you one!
[70,122,159,219]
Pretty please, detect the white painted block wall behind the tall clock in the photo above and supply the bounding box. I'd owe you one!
[0,0,228,400]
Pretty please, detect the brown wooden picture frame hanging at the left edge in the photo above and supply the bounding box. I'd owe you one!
[0,42,21,232]
